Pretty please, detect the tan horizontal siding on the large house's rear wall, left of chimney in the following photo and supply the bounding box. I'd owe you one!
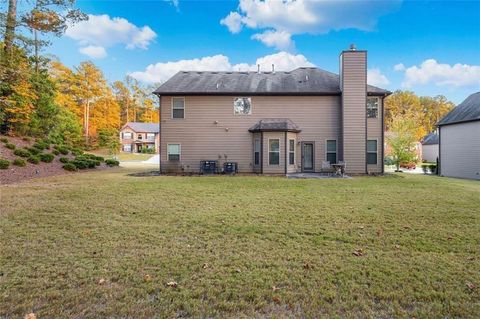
[161,96,342,174]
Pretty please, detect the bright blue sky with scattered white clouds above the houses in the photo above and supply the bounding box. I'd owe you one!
[46,0,480,103]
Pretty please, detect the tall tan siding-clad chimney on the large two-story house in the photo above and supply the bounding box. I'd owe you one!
[340,44,367,174]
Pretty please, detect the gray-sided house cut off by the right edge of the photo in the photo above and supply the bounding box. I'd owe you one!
[437,92,480,180]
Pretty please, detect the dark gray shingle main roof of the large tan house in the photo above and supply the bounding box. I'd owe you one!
[154,68,390,95]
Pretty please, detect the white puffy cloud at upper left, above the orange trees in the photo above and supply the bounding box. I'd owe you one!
[65,14,157,56]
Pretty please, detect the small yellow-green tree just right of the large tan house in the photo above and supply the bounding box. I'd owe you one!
[386,116,417,172]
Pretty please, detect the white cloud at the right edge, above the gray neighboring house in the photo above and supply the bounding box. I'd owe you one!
[402,59,480,88]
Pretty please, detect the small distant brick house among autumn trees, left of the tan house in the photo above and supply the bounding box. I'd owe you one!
[120,122,160,153]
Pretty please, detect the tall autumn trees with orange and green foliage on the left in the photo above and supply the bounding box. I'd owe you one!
[0,0,159,147]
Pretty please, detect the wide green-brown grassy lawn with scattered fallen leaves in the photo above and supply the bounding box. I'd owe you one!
[0,168,480,318]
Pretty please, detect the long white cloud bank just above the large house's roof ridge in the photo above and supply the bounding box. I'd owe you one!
[129,51,314,83]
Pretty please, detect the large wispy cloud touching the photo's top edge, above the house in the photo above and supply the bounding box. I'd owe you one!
[220,0,401,45]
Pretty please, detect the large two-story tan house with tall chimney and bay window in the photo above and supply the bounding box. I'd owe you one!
[154,48,390,174]
